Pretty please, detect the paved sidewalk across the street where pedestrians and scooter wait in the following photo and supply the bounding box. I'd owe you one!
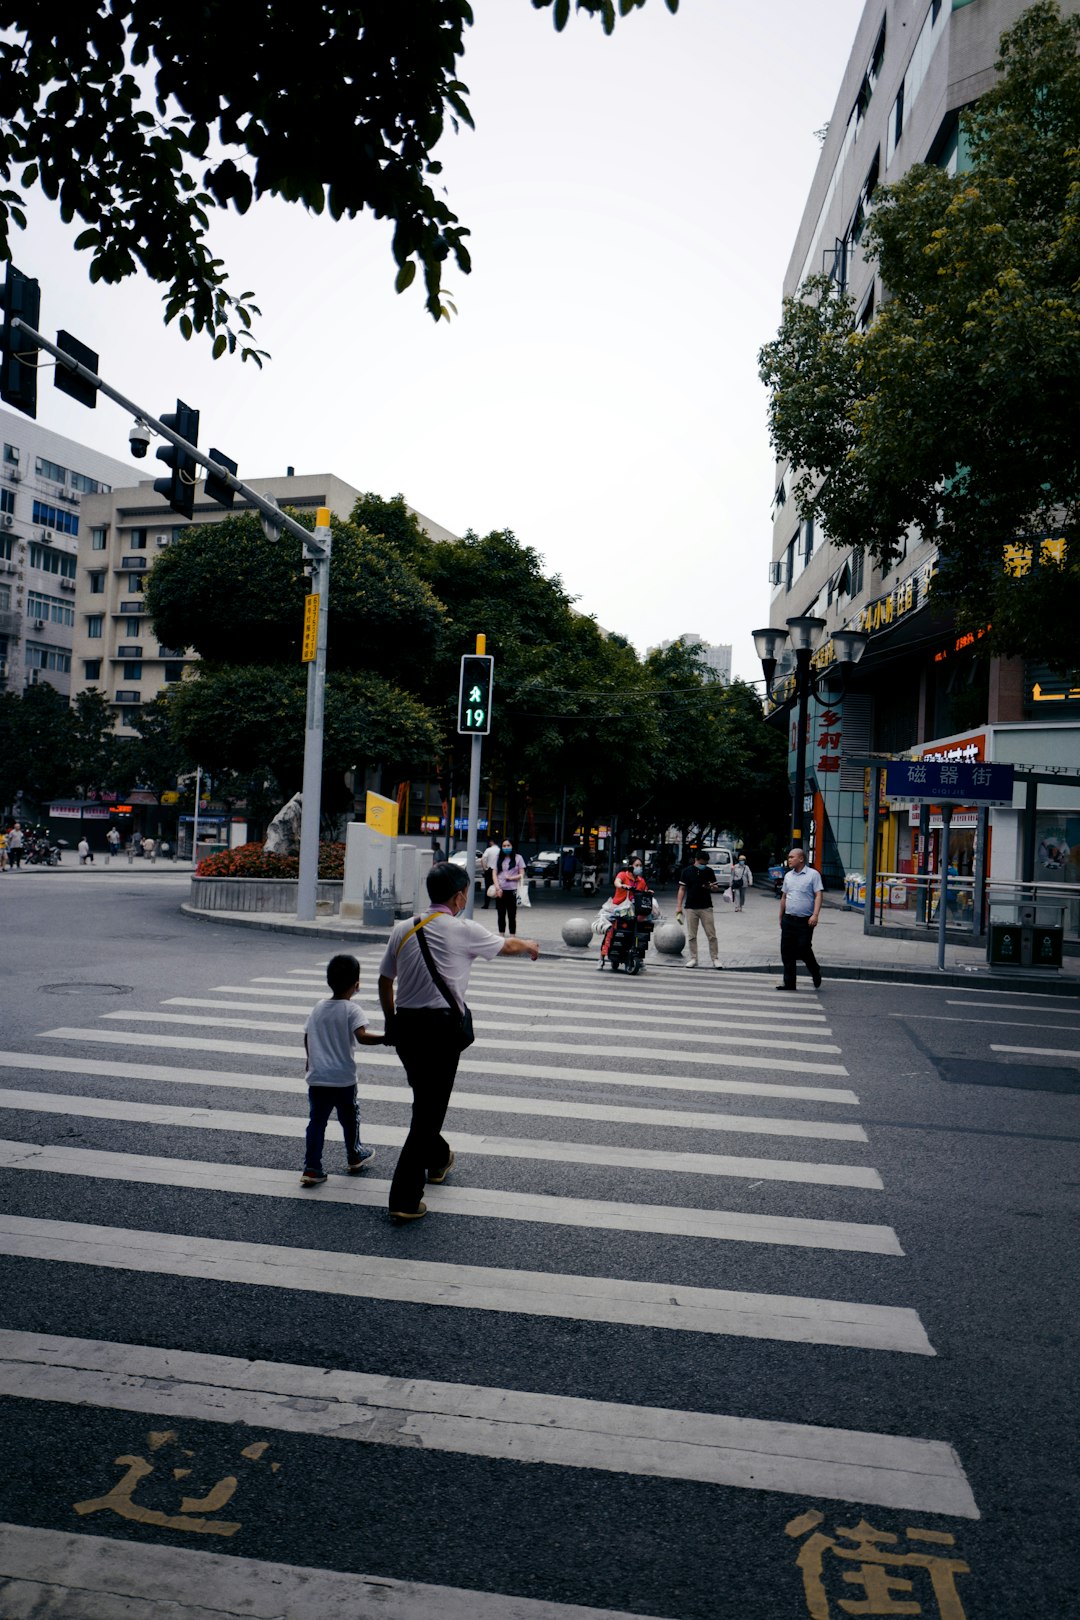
[181,885,1080,996]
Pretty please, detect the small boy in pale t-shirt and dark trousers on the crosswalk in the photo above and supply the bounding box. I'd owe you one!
[300,956,385,1187]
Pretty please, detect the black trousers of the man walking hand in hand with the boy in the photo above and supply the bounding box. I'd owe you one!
[390,1008,461,1213]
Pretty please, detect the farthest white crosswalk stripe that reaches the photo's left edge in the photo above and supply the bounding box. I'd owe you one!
[0,1051,868,1142]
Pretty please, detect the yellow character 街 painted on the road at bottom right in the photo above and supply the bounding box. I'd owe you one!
[785,1510,970,1620]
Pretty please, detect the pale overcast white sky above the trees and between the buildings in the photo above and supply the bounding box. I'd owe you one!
[13,0,863,680]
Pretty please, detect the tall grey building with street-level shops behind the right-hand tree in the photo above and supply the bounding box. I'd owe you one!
[767,0,1080,883]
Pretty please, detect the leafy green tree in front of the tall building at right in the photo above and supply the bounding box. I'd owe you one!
[759,0,1080,669]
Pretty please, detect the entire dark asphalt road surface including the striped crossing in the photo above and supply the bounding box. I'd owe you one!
[0,873,1080,1620]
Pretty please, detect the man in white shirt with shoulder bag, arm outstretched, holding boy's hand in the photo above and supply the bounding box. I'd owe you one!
[379,860,539,1221]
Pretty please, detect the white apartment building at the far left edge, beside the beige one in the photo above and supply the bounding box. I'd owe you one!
[0,410,131,697]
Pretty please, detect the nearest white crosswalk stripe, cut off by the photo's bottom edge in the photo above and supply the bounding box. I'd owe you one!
[0,1516,676,1620]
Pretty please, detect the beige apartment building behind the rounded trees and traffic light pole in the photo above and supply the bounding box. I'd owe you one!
[71,470,455,731]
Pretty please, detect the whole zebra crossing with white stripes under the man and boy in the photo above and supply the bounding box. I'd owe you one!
[0,943,997,1620]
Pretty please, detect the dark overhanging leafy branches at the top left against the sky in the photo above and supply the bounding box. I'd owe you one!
[0,0,678,363]
